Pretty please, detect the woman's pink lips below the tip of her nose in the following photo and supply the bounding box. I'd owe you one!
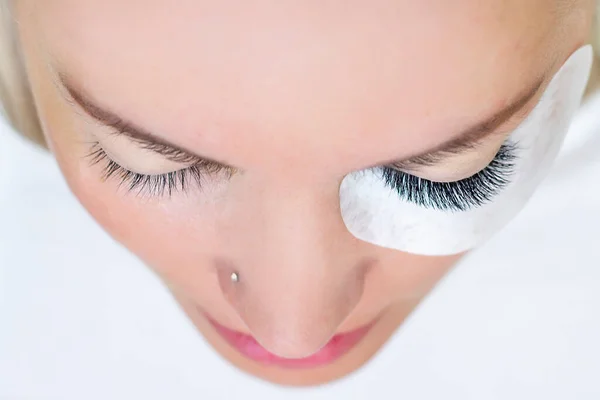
[207,316,373,369]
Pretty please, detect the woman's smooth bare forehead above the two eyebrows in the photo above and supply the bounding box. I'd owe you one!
[24,0,556,173]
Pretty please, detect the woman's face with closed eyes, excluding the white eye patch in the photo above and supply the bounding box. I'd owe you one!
[16,0,593,385]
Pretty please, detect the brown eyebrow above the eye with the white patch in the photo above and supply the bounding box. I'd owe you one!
[388,74,546,170]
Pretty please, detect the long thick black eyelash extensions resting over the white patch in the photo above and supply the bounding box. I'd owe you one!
[381,143,517,212]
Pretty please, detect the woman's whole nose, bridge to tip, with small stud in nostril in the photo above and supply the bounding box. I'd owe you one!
[216,177,371,358]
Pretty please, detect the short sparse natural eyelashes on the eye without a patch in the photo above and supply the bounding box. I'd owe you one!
[87,143,224,197]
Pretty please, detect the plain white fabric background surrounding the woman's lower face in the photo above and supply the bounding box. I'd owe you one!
[0,91,600,400]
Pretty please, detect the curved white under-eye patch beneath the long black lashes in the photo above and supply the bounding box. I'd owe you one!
[340,45,593,256]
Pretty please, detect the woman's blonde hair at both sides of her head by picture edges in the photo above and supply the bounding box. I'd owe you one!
[0,0,600,147]
